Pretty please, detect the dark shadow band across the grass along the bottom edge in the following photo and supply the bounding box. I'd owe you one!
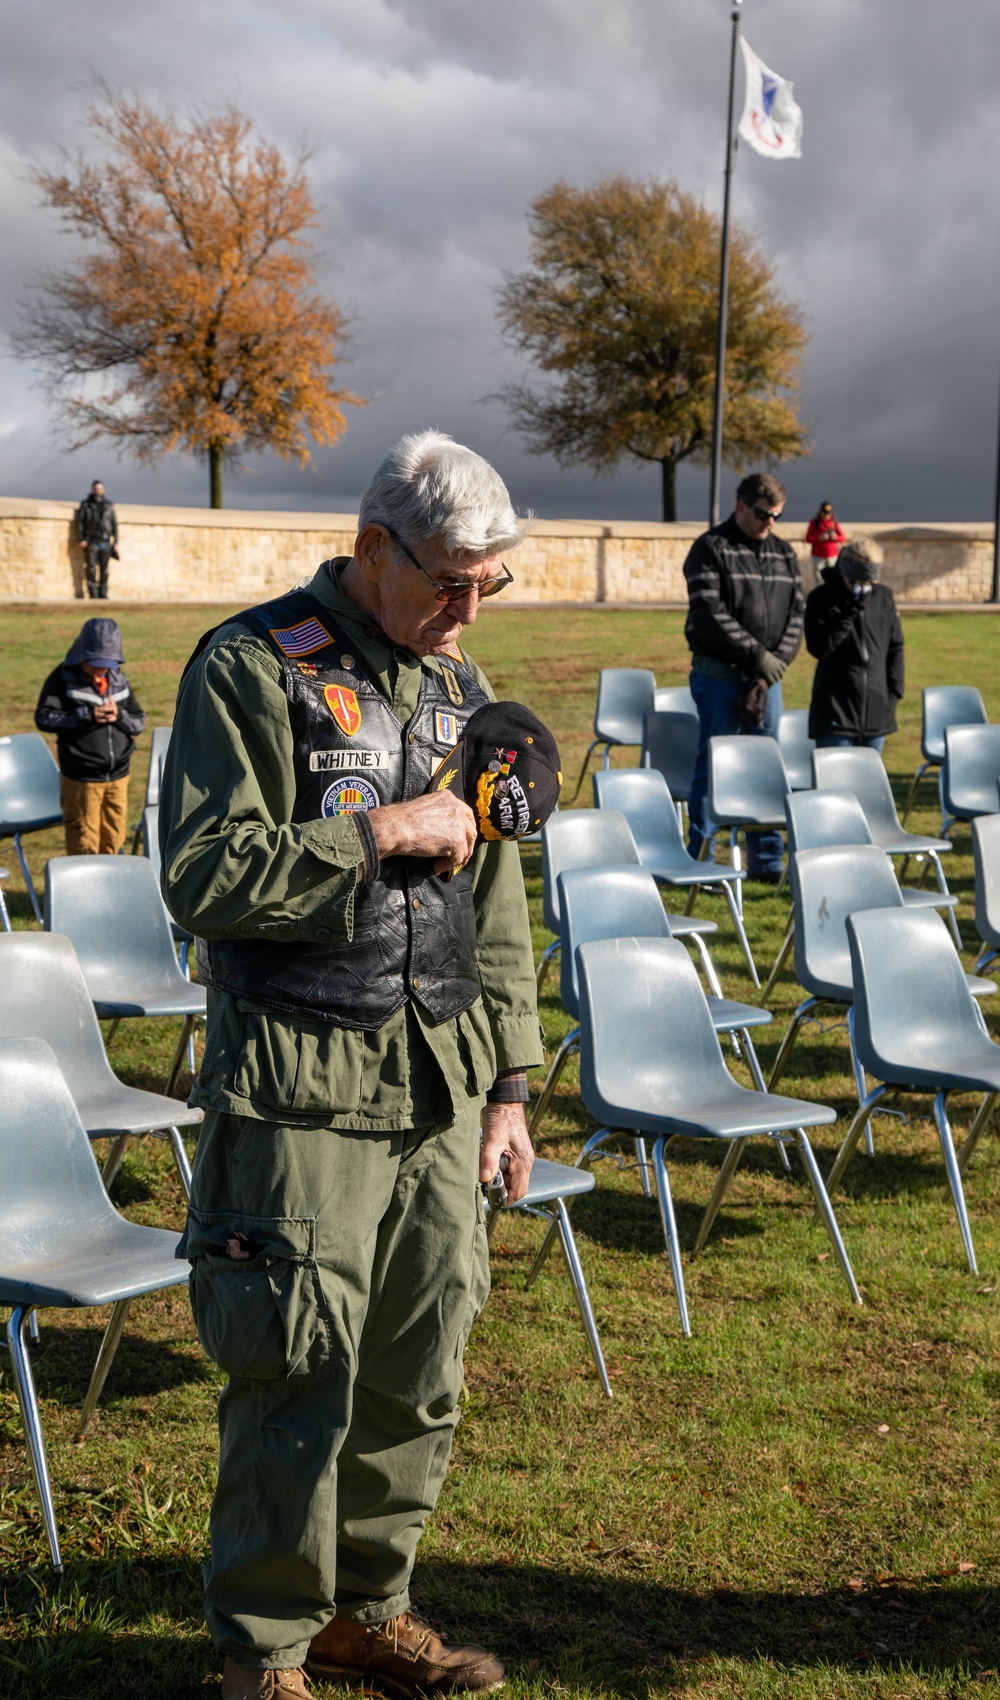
[0,1544,1000,1700]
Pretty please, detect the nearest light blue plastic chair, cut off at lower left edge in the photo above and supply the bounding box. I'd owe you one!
[0,1039,189,1573]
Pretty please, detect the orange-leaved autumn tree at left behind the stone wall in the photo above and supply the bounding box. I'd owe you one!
[17,88,364,507]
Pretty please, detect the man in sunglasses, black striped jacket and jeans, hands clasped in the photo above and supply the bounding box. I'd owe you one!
[684,473,804,886]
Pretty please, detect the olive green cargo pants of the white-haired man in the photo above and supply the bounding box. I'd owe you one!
[182,1110,490,1669]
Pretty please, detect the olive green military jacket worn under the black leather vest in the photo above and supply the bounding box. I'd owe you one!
[160,563,543,1131]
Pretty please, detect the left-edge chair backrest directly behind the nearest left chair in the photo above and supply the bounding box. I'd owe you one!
[0,932,116,1098]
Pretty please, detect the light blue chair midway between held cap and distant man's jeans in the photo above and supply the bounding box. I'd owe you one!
[594,767,760,989]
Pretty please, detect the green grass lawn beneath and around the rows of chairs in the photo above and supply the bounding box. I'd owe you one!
[0,607,1000,1700]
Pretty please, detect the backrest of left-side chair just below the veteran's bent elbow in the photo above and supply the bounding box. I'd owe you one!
[44,855,184,1003]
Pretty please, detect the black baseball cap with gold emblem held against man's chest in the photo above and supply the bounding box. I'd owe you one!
[429,702,563,840]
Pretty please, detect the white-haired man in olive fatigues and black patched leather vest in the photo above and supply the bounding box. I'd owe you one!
[160,432,543,1700]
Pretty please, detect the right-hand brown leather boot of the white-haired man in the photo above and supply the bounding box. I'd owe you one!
[306,1612,503,1697]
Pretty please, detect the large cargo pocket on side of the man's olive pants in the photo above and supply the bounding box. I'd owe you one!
[180,1210,332,1380]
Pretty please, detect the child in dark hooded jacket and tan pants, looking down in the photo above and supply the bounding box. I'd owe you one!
[34,619,146,855]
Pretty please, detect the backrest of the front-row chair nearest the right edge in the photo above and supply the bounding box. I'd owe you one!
[847,910,985,1085]
